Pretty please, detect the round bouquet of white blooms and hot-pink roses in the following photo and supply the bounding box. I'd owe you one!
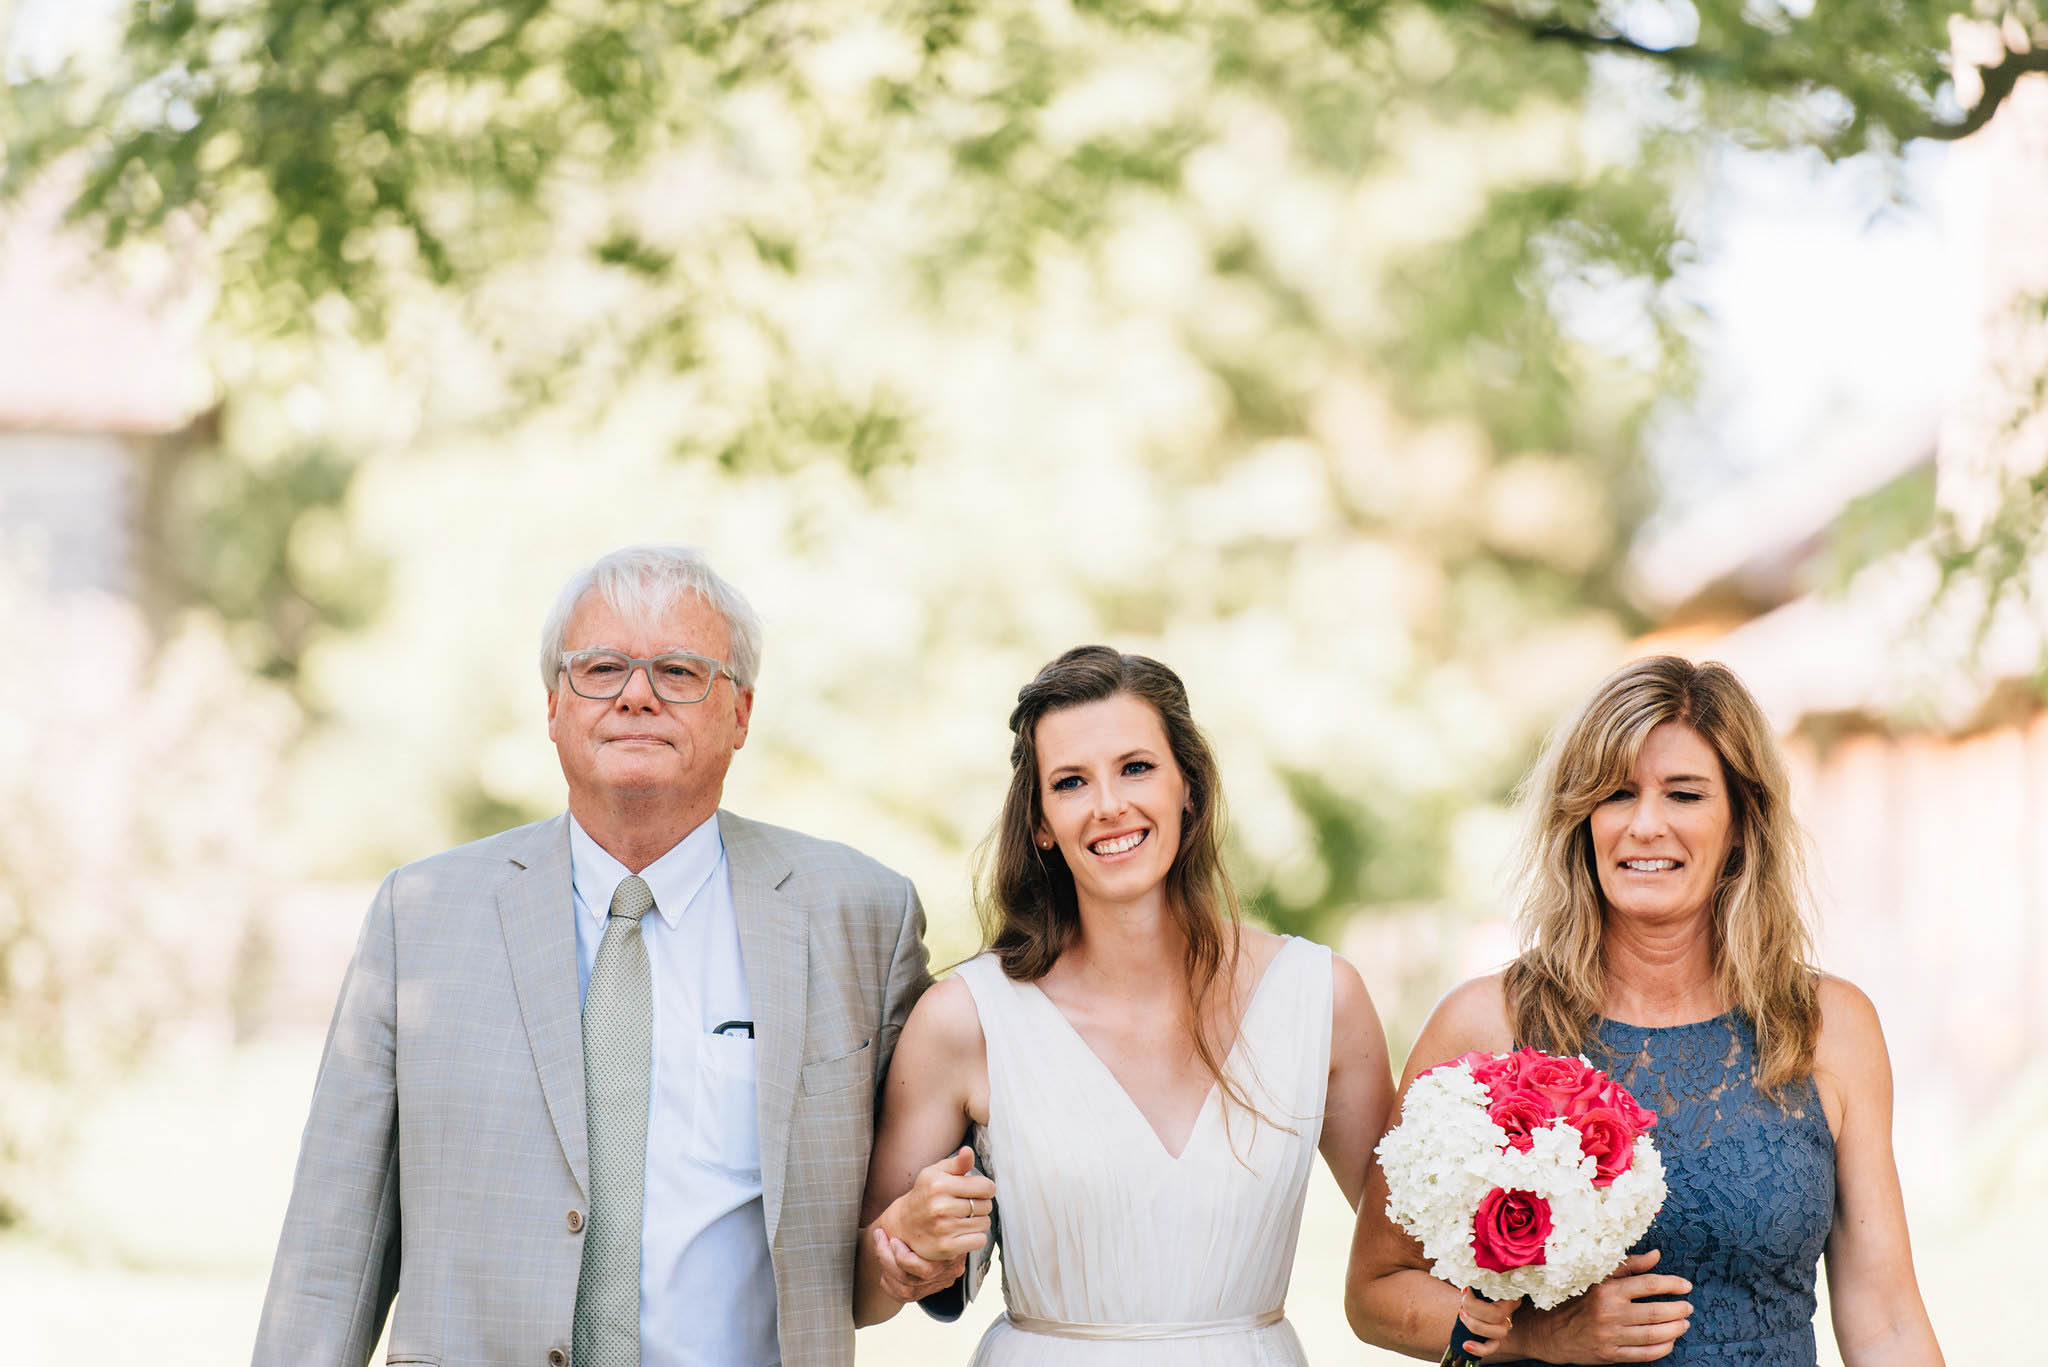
[1376,1049,1665,1363]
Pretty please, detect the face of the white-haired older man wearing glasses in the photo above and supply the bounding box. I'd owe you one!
[547,592,754,814]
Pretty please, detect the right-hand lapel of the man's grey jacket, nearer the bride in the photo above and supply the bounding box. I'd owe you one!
[719,812,811,1246]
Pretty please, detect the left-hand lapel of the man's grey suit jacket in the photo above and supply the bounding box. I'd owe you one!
[498,816,590,1197]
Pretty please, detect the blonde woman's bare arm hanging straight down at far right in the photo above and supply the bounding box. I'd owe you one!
[1815,978,1942,1367]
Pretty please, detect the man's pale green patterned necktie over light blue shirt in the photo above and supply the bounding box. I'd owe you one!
[569,875,653,1367]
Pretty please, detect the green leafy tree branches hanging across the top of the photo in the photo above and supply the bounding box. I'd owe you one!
[4,0,2048,459]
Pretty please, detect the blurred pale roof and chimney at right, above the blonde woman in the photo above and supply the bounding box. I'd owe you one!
[1632,76,2048,734]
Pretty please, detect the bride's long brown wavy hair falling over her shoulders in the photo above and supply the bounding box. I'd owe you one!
[975,646,1257,1113]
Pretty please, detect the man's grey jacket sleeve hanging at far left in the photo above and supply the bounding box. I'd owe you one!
[254,873,399,1367]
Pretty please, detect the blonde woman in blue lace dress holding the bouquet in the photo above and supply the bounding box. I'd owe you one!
[1346,656,1942,1367]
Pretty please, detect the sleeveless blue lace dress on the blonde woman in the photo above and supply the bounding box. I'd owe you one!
[1585,1010,1835,1367]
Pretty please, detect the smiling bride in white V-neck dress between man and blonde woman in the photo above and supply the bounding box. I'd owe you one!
[854,646,1393,1367]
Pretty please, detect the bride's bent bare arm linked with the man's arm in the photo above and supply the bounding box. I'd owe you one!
[854,978,995,1326]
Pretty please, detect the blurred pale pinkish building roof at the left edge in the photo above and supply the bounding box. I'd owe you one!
[0,195,211,434]
